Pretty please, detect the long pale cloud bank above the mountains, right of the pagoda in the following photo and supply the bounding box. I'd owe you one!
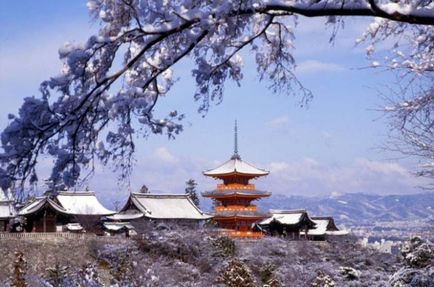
[258,158,428,196]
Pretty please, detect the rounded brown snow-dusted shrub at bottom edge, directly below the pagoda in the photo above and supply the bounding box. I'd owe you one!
[216,259,256,287]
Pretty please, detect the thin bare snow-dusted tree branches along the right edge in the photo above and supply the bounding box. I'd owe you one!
[358,9,434,182]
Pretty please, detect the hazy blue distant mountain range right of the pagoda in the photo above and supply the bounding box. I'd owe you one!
[257,192,434,225]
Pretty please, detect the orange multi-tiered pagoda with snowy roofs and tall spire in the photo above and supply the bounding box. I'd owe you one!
[202,121,271,238]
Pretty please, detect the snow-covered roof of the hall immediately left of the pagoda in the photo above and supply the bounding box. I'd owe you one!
[130,193,212,220]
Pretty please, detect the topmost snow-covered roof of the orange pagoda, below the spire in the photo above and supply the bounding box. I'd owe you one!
[203,157,269,177]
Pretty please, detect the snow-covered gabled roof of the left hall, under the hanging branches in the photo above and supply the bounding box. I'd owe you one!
[19,194,115,216]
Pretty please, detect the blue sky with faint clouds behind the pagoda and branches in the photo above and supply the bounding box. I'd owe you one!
[0,0,425,207]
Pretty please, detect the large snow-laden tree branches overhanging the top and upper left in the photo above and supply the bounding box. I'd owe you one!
[0,0,434,195]
